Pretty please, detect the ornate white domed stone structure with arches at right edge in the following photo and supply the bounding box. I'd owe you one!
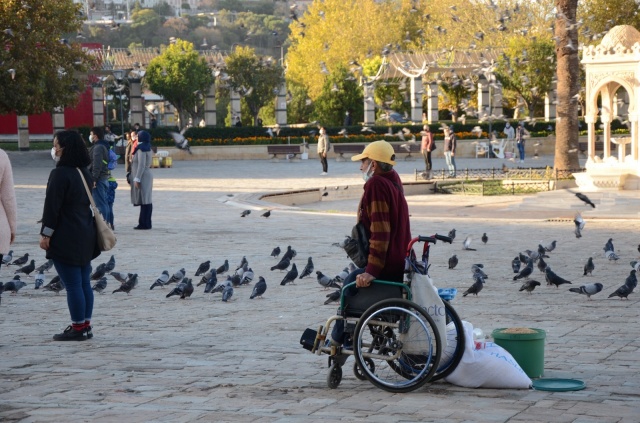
[576,25,640,191]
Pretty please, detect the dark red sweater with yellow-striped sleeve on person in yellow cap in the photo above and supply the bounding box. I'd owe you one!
[358,170,411,282]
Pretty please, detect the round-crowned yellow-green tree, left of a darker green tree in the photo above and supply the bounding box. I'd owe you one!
[145,39,214,127]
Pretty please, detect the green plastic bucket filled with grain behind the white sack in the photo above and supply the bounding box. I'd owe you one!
[491,328,547,378]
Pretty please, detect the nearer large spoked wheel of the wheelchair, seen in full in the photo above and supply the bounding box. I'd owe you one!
[353,299,441,393]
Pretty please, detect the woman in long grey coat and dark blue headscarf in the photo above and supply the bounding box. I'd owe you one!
[131,131,153,229]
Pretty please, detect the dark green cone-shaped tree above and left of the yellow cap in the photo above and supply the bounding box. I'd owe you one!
[313,66,364,126]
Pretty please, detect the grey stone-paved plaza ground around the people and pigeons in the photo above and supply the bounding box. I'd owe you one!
[0,152,640,422]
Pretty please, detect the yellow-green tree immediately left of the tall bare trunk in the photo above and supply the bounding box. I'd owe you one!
[496,37,556,118]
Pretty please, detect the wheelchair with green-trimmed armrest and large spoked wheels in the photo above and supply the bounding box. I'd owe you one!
[300,234,465,393]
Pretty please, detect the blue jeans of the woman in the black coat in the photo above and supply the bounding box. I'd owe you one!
[53,260,93,323]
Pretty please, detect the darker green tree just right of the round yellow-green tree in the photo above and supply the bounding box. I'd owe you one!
[226,47,284,125]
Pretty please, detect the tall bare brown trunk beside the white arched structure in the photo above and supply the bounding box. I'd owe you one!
[554,0,580,170]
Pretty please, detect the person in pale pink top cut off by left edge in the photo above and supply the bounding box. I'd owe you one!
[0,149,18,266]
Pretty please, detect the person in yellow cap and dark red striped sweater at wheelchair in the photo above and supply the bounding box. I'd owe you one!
[330,141,411,352]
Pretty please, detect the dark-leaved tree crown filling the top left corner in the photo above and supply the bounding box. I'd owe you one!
[0,0,97,115]
